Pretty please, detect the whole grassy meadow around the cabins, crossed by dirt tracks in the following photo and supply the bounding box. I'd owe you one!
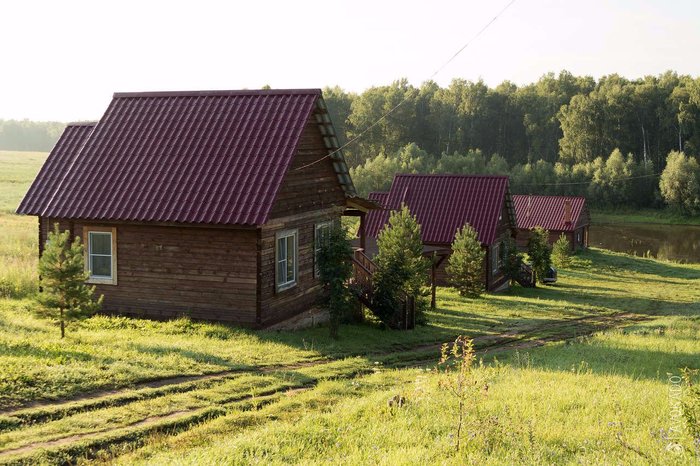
[0,153,700,464]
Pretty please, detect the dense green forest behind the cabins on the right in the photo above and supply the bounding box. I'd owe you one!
[324,71,700,212]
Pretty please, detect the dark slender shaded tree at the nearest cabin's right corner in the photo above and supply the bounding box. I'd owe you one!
[318,223,352,338]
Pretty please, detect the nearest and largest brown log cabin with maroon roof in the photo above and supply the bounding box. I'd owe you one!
[17,90,373,327]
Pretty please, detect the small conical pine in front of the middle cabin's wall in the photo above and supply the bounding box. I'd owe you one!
[445,223,486,298]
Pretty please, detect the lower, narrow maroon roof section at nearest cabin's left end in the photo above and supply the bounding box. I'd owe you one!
[17,122,97,215]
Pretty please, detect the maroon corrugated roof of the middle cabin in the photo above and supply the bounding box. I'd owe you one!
[366,175,515,244]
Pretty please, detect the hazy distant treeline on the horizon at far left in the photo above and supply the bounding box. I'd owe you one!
[0,120,66,152]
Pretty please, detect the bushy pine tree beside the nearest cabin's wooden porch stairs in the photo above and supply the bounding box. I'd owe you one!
[373,205,430,328]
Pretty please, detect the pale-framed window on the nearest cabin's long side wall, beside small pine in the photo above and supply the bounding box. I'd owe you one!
[84,227,117,285]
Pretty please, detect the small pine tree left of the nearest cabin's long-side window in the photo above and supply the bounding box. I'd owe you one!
[39,224,103,338]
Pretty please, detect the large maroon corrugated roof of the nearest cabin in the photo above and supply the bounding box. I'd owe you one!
[18,89,354,225]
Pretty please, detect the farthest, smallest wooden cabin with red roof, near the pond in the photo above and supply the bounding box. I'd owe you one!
[513,194,591,250]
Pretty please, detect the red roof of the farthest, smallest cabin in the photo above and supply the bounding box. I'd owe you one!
[513,195,586,231]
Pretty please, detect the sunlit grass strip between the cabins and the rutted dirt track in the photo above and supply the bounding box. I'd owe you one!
[0,250,700,409]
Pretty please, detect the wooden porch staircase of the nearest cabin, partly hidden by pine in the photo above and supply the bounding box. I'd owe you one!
[350,249,416,330]
